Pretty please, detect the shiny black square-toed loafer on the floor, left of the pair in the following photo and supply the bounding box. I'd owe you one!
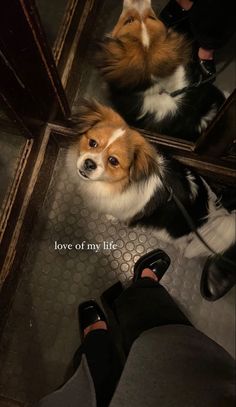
[78,300,107,337]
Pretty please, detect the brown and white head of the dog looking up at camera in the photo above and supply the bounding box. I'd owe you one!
[70,101,157,190]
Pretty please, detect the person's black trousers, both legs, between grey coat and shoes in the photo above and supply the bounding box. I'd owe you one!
[77,278,191,407]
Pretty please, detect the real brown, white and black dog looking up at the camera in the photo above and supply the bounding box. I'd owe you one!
[67,101,235,258]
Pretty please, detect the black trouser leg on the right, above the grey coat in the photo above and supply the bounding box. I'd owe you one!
[114,278,191,353]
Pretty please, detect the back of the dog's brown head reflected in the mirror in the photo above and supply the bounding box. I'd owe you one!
[95,0,189,88]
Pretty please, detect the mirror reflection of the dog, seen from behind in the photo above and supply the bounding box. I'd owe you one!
[94,0,225,141]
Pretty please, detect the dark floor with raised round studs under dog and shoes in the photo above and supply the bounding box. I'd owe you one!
[0,149,235,401]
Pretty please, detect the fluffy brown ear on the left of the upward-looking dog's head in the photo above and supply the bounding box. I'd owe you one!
[71,99,124,134]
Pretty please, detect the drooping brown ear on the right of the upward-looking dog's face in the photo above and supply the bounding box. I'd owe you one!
[130,132,158,182]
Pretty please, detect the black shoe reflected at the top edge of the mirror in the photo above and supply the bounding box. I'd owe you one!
[158,0,189,27]
